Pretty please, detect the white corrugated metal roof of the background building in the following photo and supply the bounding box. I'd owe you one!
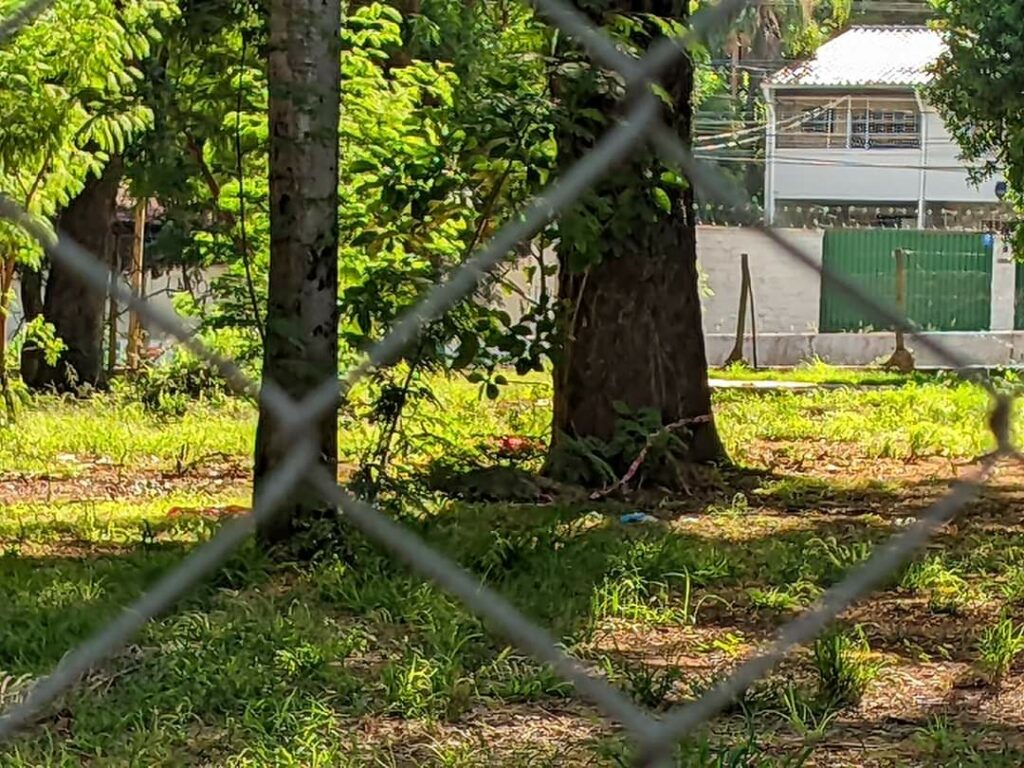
[768,26,944,88]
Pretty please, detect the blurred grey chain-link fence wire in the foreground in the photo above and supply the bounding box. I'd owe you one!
[0,0,1017,766]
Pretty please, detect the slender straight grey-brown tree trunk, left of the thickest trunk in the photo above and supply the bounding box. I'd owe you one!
[255,0,341,546]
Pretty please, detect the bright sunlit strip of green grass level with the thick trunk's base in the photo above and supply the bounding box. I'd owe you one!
[0,366,1007,475]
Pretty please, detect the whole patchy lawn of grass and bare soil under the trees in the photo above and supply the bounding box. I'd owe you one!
[0,372,1024,768]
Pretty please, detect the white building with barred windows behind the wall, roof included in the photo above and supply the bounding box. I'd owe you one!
[763,26,1004,230]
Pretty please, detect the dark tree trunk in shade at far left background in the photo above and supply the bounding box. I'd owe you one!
[22,160,122,391]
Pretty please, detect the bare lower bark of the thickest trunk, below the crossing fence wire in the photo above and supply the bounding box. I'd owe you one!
[553,214,722,462]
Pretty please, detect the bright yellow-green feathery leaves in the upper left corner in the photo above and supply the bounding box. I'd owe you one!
[0,0,177,417]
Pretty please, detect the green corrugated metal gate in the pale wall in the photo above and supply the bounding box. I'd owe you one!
[819,229,992,333]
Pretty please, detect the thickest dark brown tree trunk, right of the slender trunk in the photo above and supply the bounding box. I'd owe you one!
[548,0,723,481]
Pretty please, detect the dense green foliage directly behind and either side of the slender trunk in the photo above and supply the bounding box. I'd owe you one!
[136,2,553,385]
